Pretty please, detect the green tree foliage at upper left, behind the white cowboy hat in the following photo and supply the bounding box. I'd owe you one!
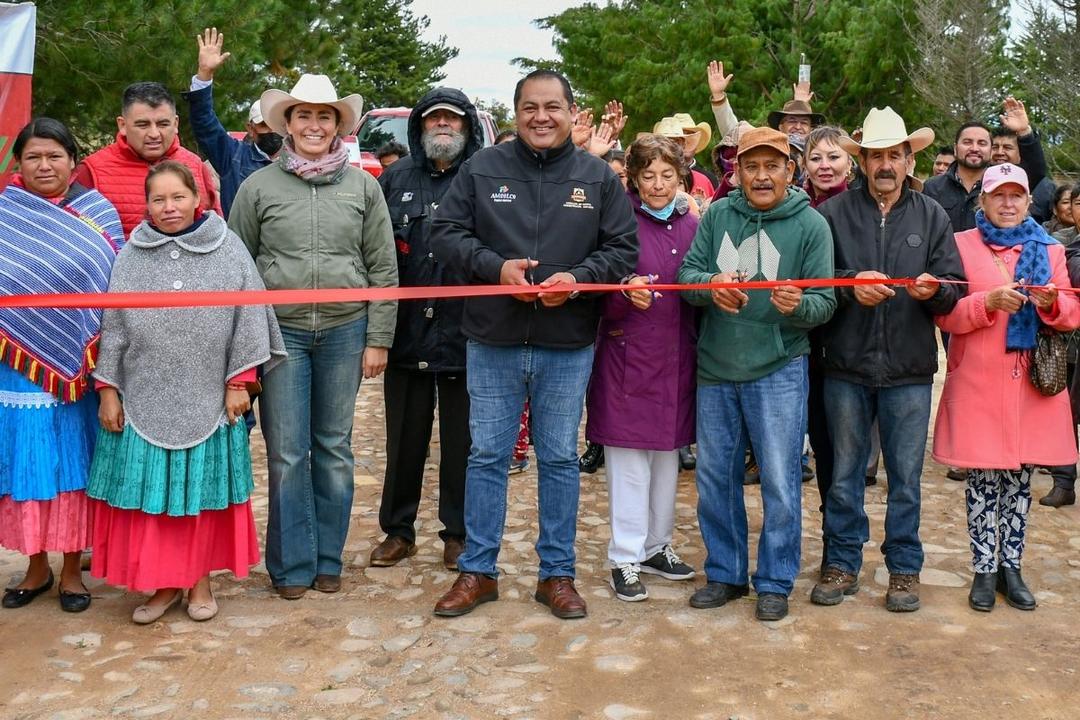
[33,0,457,148]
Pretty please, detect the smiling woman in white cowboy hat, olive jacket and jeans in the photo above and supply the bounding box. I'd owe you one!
[229,74,397,600]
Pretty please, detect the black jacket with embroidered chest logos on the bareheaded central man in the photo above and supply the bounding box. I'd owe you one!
[431,138,637,349]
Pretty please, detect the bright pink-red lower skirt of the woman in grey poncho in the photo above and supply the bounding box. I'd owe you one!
[90,499,259,593]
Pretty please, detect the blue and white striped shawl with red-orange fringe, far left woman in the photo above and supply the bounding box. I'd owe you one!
[0,186,124,402]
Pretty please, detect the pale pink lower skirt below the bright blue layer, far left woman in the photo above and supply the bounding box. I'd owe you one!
[0,490,91,555]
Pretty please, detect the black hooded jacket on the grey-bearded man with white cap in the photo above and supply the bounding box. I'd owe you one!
[379,87,484,372]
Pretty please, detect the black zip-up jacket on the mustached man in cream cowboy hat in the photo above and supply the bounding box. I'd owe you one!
[818,184,964,388]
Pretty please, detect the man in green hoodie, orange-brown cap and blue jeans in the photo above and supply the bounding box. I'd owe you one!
[678,127,836,621]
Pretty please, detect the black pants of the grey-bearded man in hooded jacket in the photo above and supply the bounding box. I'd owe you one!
[379,366,472,542]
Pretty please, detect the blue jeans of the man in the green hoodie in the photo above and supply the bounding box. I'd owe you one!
[697,357,808,596]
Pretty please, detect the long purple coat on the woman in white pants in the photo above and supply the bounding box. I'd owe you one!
[585,193,698,450]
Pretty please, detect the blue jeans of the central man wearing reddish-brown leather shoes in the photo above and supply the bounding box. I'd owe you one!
[458,340,593,580]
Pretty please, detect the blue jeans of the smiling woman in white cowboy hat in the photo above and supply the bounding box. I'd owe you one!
[259,317,367,587]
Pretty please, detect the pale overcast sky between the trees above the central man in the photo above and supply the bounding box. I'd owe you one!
[411,0,583,106]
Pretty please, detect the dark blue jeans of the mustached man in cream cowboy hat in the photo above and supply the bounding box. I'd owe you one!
[824,378,932,574]
